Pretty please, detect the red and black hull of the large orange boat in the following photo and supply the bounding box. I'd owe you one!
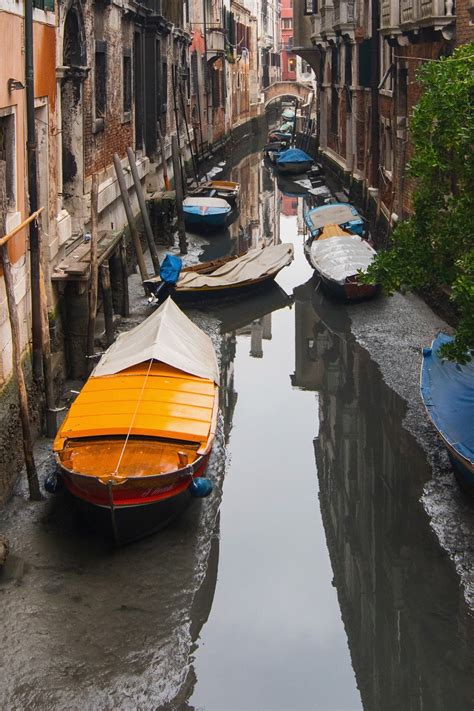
[60,454,209,546]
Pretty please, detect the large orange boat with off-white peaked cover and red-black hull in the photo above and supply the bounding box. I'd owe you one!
[53,299,219,544]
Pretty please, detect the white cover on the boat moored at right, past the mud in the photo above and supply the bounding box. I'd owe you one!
[310,235,376,284]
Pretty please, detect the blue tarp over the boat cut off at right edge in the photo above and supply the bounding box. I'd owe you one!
[421,333,474,464]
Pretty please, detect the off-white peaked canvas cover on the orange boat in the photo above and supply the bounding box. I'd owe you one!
[92,298,219,384]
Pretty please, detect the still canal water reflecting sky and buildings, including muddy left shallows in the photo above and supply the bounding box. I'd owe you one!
[0,146,474,711]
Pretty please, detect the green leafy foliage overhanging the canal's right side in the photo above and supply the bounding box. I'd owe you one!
[370,43,474,362]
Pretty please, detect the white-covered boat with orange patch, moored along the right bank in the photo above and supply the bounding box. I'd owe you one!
[305,225,380,301]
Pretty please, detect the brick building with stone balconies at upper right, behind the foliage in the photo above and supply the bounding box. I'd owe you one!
[294,0,474,224]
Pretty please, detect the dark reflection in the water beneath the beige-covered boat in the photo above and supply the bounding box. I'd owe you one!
[213,282,293,333]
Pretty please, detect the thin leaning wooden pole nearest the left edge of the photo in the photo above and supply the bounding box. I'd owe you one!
[0,160,42,501]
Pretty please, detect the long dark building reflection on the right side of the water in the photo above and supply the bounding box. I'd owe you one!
[293,290,474,711]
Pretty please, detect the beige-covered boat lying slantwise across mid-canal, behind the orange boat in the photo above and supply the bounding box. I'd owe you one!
[144,244,294,302]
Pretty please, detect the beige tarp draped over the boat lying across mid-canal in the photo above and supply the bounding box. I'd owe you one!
[176,243,294,290]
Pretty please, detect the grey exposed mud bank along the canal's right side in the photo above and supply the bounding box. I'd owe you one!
[349,294,474,610]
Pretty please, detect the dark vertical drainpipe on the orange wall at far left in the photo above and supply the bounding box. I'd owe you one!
[25,0,43,381]
